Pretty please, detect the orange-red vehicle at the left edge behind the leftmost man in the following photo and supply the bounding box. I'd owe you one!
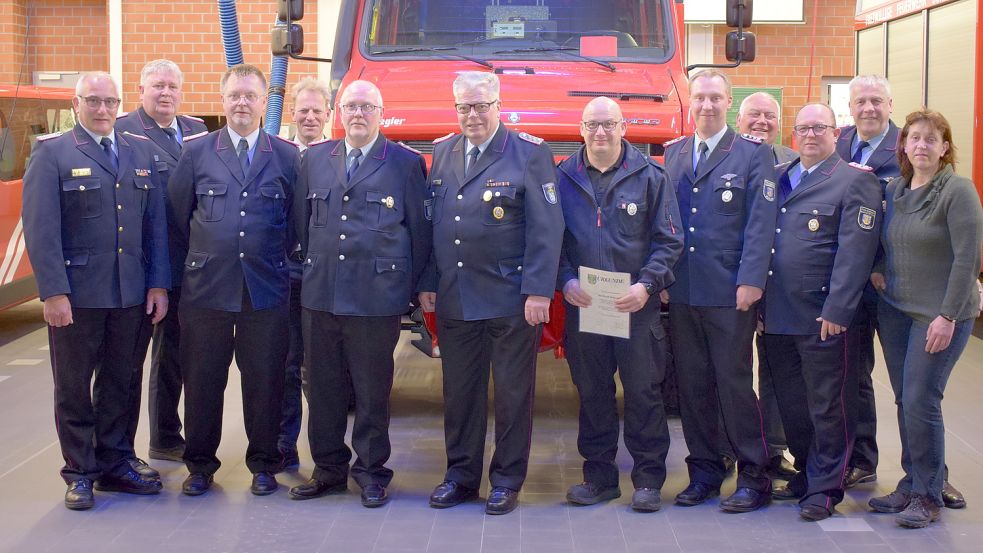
[0,85,75,310]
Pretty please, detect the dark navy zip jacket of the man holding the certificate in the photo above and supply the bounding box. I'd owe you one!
[556,139,683,290]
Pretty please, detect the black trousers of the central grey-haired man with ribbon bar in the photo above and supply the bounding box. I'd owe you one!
[437,315,542,490]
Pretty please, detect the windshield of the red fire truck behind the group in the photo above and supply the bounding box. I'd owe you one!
[361,0,674,63]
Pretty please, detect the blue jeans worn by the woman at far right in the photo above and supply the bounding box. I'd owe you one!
[877,300,973,505]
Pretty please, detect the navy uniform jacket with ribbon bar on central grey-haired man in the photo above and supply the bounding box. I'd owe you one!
[421,124,563,321]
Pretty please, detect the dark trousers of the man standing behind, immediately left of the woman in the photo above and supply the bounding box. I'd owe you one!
[847,282,878,472]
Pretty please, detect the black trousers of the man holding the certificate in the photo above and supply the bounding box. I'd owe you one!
[565,298,669,489]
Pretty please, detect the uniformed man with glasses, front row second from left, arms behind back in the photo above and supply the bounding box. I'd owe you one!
[167,65,300,495]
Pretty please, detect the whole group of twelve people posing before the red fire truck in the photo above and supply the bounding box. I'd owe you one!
[23,60,983,527]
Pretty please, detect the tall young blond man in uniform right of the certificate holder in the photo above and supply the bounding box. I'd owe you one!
[663,70,776,512]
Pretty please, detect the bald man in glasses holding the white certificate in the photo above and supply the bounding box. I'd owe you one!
[556,97,683,512]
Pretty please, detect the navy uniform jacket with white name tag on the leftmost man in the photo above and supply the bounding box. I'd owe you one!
[23,125,171,308]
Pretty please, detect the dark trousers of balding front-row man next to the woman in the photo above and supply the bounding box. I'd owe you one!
[765,333,856,511]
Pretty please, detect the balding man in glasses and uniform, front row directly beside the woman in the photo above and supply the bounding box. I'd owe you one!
[764,104,882,520]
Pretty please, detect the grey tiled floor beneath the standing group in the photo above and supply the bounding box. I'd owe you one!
[0,302,983,553]
